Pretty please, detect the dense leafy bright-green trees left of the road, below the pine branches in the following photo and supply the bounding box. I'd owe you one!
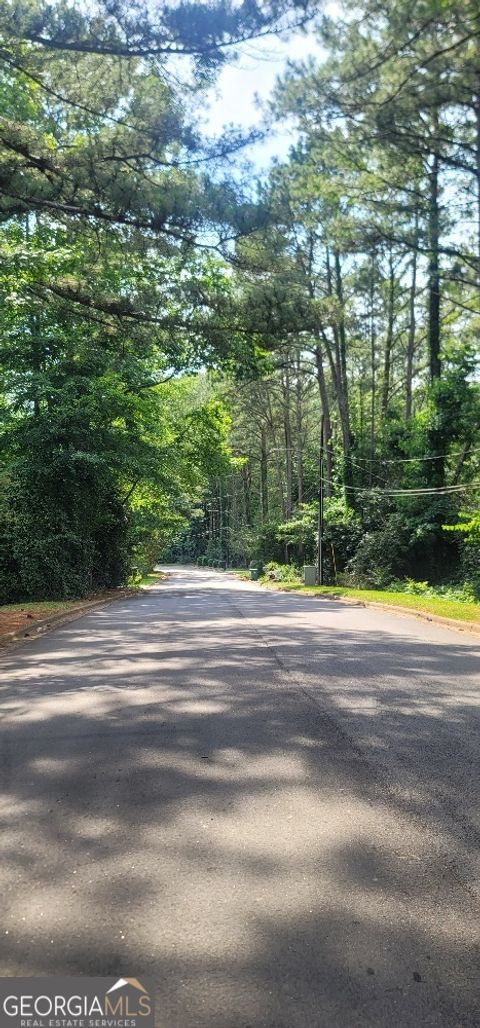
[0,277,235,598]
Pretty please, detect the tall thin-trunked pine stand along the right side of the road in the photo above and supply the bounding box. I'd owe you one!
[170,0,480,590]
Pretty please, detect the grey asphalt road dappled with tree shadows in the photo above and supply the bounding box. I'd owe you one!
[0,568,480,1028]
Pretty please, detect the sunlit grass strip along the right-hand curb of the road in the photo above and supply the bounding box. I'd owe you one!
[230,572,480,622]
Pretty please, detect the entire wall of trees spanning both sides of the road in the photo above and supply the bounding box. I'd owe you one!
[0,0,480,599]
